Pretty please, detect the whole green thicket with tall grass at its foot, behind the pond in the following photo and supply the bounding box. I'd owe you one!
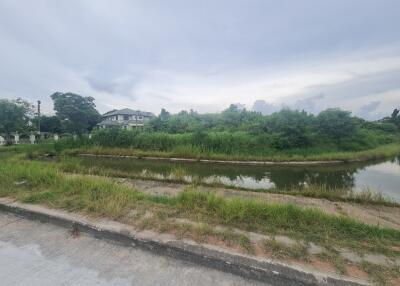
[89,105,400,155]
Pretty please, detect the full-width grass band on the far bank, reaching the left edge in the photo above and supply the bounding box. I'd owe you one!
[0,129,400,162]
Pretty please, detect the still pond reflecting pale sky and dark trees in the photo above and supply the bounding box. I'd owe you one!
[80,157,400,201]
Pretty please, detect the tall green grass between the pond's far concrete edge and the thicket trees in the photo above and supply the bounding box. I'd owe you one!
[66,129,400,161]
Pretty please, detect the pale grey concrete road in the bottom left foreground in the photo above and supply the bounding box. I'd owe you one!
[0,212,265,286]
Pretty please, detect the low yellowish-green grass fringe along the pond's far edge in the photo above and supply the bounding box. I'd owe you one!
[0,137,400,163]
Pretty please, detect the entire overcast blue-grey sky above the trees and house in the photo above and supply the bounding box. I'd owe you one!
[0,0,400,119]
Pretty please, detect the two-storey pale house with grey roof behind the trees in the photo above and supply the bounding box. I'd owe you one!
[97,108,155,129]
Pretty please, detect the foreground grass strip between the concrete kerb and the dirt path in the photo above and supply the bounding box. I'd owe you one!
[0,158,400,253]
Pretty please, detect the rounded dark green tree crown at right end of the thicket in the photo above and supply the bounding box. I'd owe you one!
[317,108,356,139]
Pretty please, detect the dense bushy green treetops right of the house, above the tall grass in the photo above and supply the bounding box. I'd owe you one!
[141,105,400,152]
